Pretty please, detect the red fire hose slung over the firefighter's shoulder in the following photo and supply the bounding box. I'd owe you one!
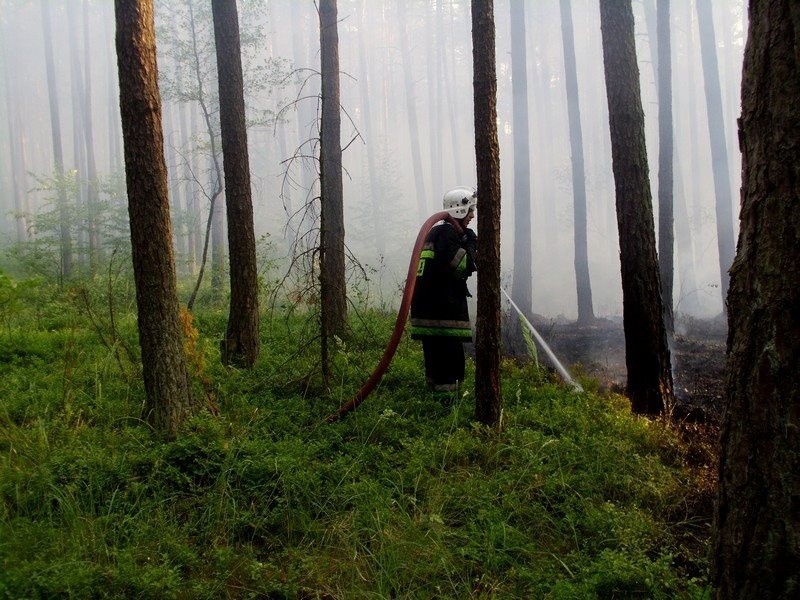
[327,211,463,423]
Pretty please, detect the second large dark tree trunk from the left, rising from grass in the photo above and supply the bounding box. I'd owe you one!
[211,0,260,368]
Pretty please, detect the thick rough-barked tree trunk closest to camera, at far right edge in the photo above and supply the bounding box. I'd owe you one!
[712,0,800,600]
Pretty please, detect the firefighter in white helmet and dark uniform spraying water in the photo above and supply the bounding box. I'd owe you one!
[411,187,478,395]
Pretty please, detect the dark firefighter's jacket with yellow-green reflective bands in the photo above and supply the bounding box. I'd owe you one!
[411,222,478,342]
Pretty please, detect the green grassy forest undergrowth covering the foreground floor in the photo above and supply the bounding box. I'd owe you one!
[0,275,713,599]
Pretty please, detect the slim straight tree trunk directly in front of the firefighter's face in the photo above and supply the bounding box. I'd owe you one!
[472,0,502,425]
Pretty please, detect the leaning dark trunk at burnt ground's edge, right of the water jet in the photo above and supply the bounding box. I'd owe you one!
[600,0,674,415]
